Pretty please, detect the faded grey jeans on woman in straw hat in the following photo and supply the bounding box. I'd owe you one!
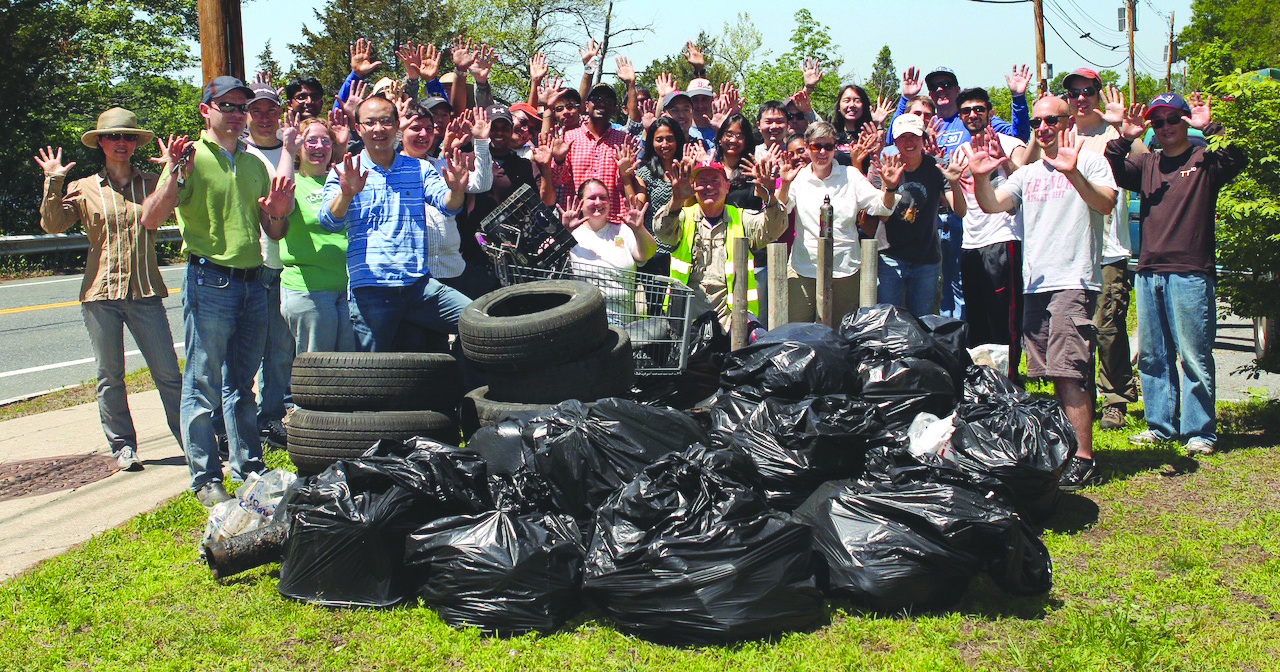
[81,297,182,454]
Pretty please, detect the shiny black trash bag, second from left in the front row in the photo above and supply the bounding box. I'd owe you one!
[404,511,584,636]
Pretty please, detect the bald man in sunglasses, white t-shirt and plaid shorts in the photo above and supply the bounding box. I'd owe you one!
[969,97,1116,492]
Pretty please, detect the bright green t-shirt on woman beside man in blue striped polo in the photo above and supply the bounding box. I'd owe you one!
[280,174,347,292]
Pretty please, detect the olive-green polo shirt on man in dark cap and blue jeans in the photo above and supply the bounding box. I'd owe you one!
[157,131,271,269]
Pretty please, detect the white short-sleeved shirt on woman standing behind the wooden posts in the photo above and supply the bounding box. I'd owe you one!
[787,163,902,278]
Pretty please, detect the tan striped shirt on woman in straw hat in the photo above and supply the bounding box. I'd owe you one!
[40,168,169,301]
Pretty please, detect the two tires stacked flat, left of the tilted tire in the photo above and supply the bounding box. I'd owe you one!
[287,352,462,474]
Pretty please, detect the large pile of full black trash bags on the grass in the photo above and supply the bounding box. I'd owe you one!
[207,306,1076,644]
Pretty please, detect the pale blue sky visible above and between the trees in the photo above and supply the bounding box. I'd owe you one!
[220,0,1190,86]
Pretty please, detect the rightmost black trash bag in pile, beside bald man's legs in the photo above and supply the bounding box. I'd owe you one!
[951,396,1076,522]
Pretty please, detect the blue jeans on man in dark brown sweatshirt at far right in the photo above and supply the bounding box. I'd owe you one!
[1135,271,1217,442]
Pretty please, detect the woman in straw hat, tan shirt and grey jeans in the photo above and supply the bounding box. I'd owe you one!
[35,108,182,471]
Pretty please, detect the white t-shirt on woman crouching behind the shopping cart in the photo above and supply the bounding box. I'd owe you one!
[568,223,639,316]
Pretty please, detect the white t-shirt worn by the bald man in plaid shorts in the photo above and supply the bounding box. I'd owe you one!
[1000,150,1116,294]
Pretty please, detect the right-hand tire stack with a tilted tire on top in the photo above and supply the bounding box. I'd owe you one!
[458,280,635,436]
